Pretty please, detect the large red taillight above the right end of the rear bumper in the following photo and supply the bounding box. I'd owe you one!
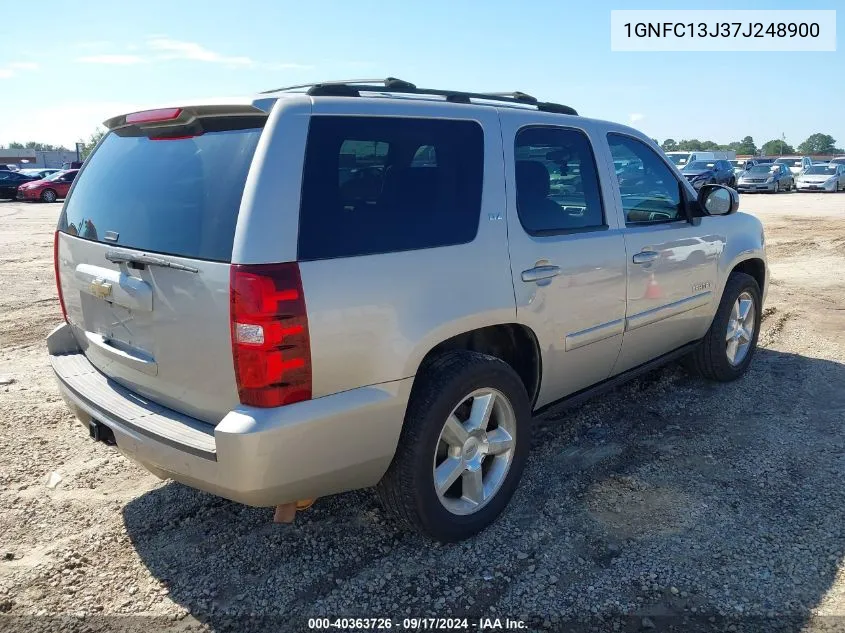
[230,263,311,407]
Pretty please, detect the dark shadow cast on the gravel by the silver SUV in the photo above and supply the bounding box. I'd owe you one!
[123,349,845,631]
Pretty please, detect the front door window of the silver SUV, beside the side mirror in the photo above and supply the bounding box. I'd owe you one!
[607,134,684,223]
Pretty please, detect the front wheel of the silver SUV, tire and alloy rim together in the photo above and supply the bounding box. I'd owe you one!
[689,273,762,382]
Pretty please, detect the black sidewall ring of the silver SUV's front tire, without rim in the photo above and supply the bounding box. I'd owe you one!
[706,273,762,381]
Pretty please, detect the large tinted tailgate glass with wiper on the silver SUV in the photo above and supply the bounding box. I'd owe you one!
[59,123,261,262]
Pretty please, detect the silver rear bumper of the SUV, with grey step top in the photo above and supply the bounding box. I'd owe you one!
[47,325,413,506]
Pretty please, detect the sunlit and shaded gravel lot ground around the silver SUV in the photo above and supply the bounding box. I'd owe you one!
[0,194,845,633]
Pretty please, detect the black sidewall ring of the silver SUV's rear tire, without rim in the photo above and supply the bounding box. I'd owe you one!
[406,358,531,541]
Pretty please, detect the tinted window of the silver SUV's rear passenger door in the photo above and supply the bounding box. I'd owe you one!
[514,127,604,235]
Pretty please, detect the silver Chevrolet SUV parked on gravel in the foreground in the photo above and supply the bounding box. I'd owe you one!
[48,79,768,541]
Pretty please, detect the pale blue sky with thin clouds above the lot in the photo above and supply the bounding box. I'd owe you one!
[0,0,845,147]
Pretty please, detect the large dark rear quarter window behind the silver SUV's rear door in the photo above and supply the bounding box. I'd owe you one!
[299,116,484,260]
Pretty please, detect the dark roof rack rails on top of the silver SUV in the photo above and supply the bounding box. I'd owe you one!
[261,77,578,115]
